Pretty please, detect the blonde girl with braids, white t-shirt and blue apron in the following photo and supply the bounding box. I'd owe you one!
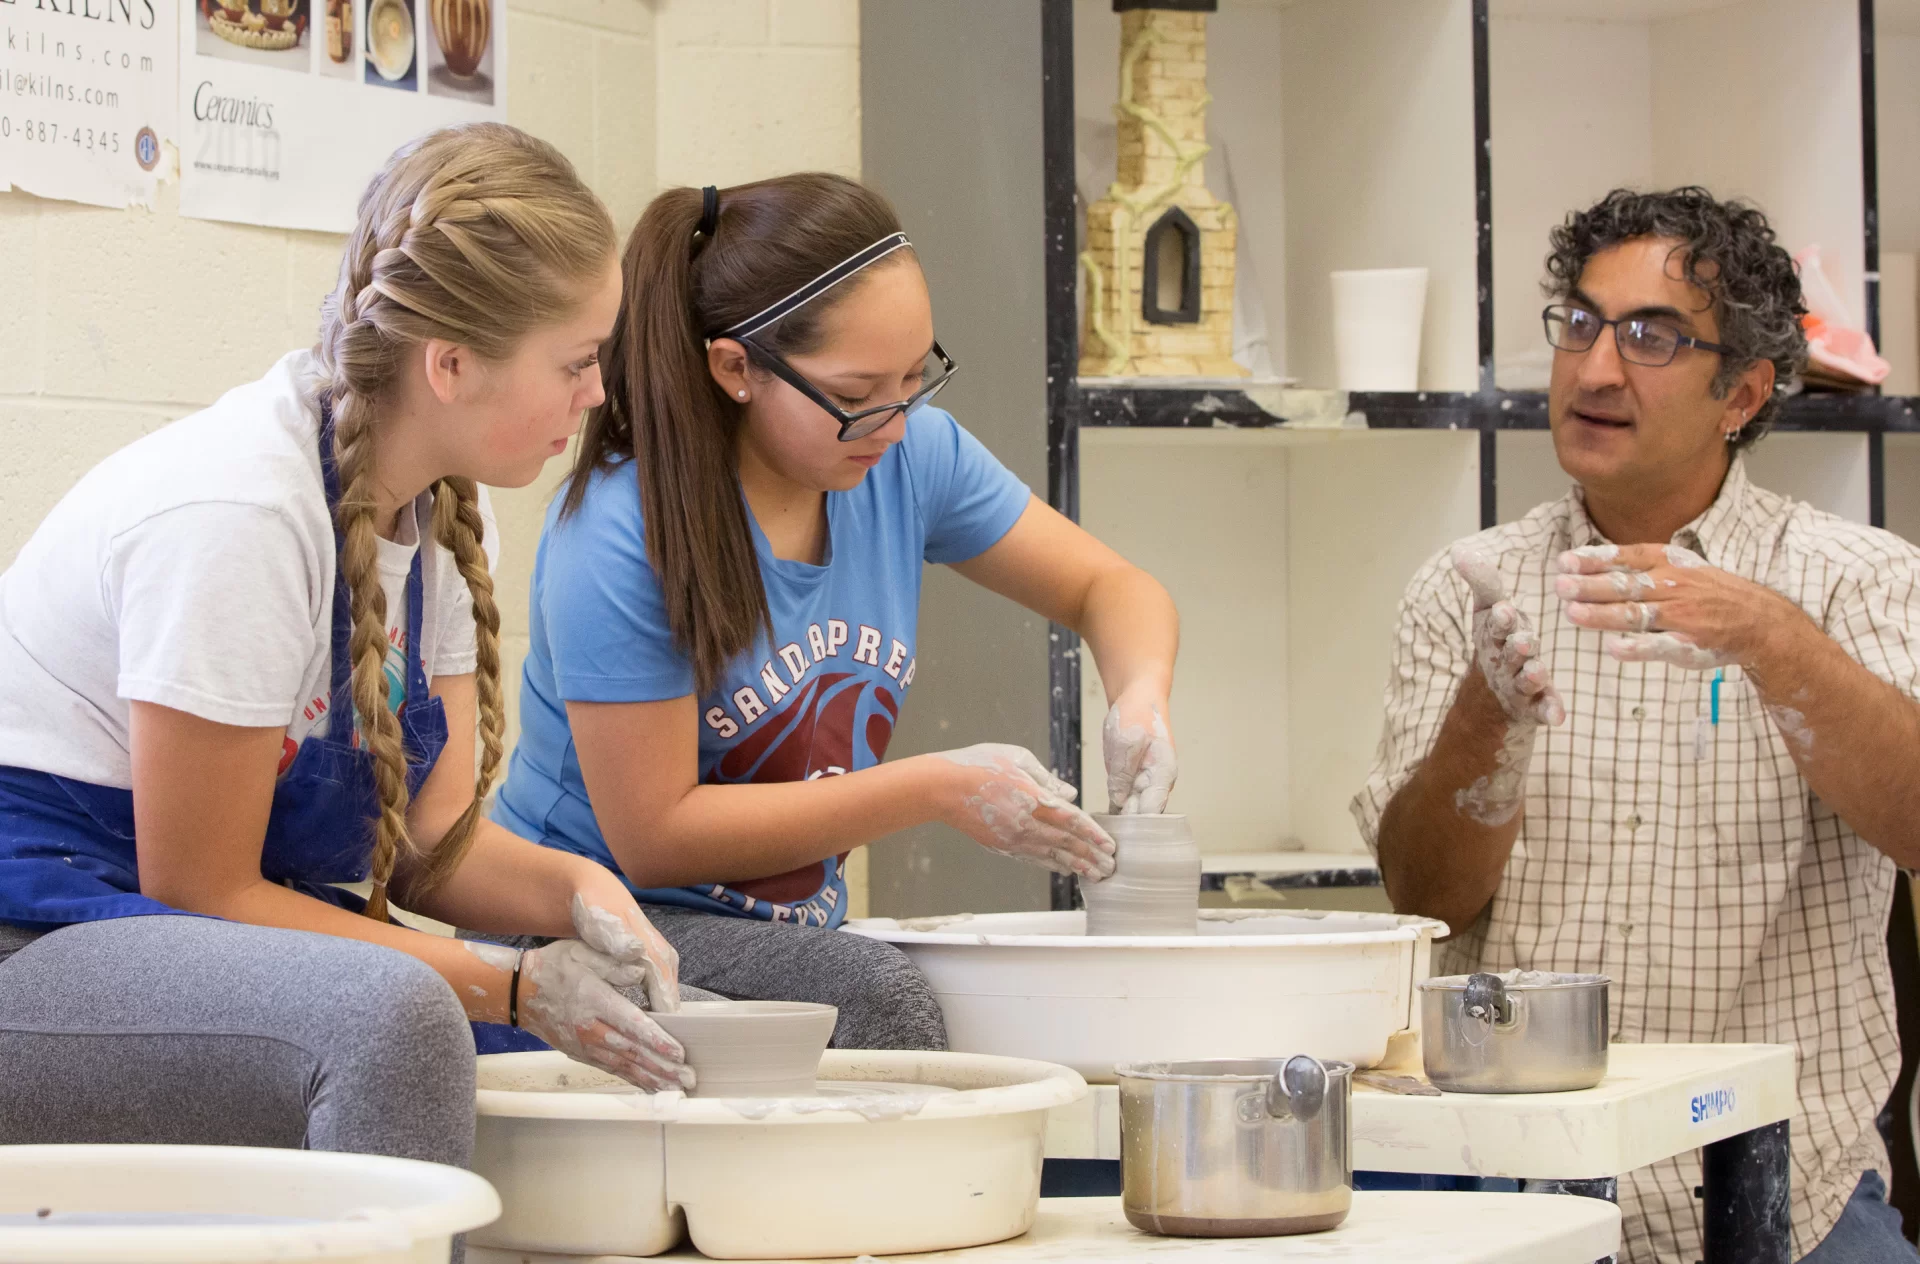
[0,125,691,1164]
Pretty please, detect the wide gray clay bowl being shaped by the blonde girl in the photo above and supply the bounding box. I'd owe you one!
[653,1001,839,1097]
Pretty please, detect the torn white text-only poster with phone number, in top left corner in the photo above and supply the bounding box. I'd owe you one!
[0,0,180,207]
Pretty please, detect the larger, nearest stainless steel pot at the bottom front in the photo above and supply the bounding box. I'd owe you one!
[1114,1055,1354,1237]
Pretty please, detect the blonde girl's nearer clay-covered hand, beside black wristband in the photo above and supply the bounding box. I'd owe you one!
[520,939,693,1091]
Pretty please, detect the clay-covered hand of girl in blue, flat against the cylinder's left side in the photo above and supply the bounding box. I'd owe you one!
[933,741,1114,882]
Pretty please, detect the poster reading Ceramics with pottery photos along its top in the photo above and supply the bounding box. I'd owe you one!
[178,0,507,232]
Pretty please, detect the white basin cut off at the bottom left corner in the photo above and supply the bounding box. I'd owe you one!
[0,1145,499,1264]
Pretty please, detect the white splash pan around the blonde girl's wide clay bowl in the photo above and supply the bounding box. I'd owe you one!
[467,1051,1087,1264]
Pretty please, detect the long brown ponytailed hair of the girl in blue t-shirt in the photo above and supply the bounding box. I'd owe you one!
[561,173,900,693]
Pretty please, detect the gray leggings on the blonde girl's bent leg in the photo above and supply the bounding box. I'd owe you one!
[0,916,474,1168]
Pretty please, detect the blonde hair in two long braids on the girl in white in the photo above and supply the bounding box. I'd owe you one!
[315,123,616,920]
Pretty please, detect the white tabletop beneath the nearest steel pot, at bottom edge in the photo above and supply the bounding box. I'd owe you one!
[655,1193,1620,1264]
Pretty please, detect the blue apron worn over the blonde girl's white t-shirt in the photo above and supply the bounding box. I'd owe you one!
[0,403,447,930]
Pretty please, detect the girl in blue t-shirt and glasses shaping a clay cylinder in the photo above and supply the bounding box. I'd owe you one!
[495,175,1179,1049]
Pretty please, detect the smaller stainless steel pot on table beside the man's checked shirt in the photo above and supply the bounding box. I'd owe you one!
[1421,970,1609,1093]
